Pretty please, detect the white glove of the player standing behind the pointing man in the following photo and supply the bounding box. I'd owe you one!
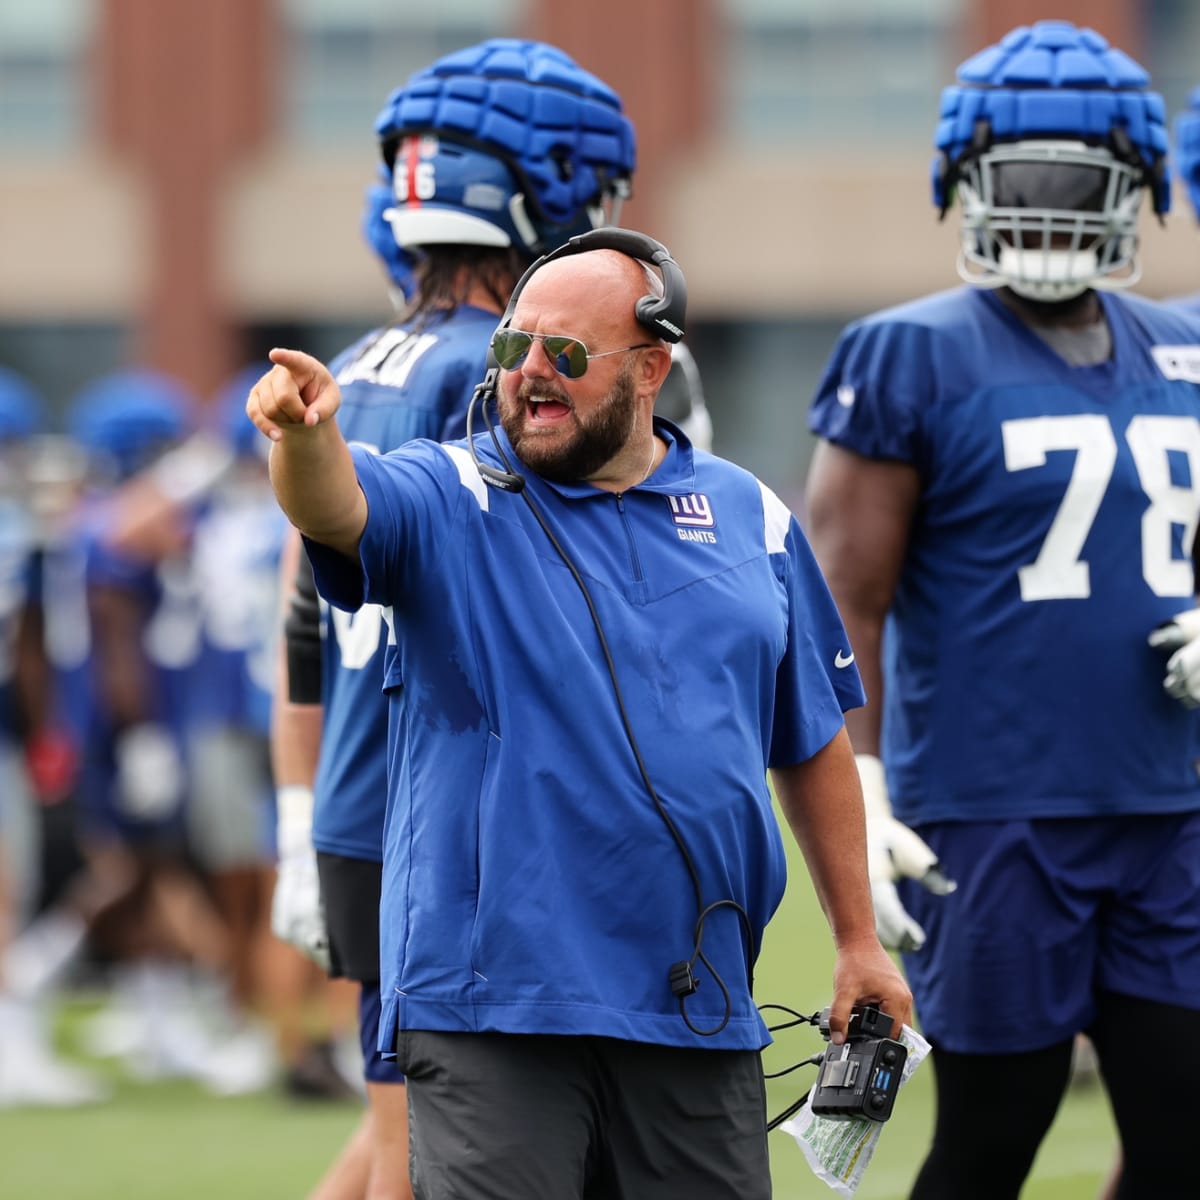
[271,785,330,971]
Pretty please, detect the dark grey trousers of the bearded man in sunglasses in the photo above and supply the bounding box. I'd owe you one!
[396,1030,770,1200]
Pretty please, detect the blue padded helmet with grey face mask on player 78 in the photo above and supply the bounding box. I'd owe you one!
[932,20,1170,301]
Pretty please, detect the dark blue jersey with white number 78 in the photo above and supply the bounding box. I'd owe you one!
[810,288,1200,823]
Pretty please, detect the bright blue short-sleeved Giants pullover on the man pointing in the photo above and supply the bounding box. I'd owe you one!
[310,420,862,1050]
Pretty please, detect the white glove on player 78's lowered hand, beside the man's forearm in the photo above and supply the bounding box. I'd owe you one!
[854,754,958,950]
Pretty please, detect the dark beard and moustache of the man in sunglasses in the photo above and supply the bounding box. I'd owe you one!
[499,366,636,484]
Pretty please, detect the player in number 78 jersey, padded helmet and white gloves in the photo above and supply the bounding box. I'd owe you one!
[808,22,1200,1200]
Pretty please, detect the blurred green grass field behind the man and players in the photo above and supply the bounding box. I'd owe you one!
[0,816,1115,1200]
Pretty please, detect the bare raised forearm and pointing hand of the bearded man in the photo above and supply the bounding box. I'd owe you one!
[246,349,367,560]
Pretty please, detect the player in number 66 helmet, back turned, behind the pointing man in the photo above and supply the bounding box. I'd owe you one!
[275,38,652,1198]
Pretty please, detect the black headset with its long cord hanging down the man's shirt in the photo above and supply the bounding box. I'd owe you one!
[467,228,754,1037]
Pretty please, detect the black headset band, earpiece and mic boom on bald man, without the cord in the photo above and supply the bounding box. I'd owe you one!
[467,227,688,492]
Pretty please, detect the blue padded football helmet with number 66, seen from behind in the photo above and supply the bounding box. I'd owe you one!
[376,38,635,258]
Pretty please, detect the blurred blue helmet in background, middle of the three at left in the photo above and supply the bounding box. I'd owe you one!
[67,368,197,479]
